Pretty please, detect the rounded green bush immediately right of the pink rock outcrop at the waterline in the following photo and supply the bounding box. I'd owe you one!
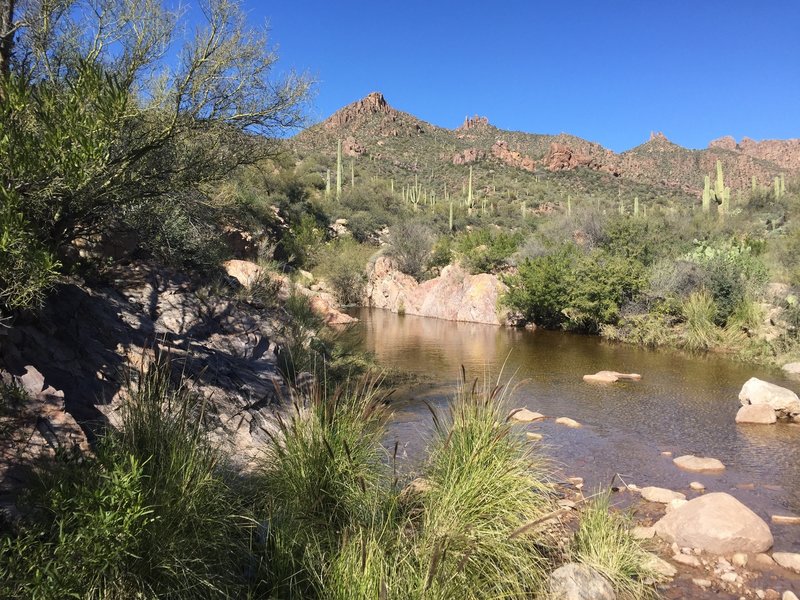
[502,244,580,327]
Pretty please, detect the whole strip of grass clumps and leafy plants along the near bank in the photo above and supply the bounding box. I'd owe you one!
[0,360,653,599]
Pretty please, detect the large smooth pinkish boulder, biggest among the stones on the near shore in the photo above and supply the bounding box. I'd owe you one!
[655,492,773,555]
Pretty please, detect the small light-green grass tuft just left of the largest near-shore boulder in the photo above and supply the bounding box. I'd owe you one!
[571,493,656,600]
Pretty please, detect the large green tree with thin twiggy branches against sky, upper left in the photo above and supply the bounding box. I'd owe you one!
[0,0,311,314]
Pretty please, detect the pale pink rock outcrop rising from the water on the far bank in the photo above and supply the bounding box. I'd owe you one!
[365,256,505,325]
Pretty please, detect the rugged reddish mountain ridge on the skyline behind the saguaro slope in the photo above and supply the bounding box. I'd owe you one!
[292,92,800,202]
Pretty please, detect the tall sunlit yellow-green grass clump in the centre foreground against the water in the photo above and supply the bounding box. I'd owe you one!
[413,372,552,598]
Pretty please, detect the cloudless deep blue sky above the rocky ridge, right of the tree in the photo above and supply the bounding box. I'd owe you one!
[244,0,800,151]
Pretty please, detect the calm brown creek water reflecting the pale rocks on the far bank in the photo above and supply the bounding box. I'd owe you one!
[354,309,800,552]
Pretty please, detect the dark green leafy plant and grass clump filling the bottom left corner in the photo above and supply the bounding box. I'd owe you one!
[0,361,250,599]
